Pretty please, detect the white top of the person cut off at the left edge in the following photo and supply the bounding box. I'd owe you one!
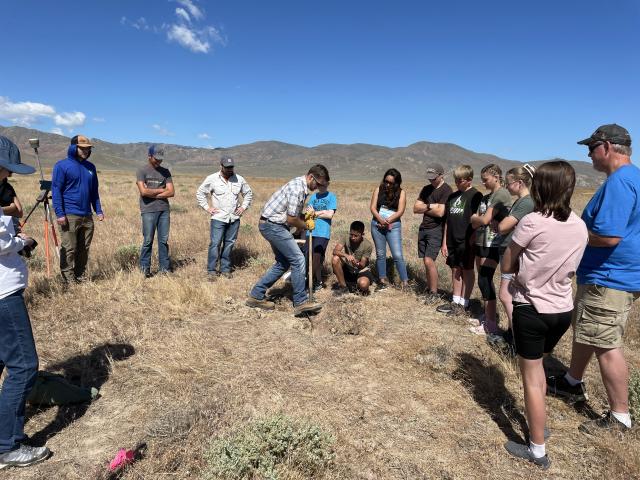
[0,211,28,299]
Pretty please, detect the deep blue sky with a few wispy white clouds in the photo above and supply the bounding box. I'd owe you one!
[0,0,640,161]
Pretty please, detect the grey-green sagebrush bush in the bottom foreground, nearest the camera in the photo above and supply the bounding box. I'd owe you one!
[204,415,334,480]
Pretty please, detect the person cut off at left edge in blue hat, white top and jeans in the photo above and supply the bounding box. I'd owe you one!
[0,136,51,470]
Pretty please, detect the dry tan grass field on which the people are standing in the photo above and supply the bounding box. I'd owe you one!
[0,170,640,480]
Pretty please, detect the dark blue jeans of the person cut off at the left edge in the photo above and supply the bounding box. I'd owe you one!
[0,290,38,453]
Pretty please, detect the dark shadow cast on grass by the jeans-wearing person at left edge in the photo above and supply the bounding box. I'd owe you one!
[31,343,135,445]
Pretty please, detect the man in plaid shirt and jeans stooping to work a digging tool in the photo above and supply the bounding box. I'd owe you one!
[246,165,330,316]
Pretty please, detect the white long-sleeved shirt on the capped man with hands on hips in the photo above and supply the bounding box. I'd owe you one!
[196,171,253,223]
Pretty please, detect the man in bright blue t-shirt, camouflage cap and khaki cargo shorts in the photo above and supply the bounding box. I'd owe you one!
[548,124,640,434]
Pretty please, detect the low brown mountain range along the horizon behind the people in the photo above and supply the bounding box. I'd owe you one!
[0,126,604,187]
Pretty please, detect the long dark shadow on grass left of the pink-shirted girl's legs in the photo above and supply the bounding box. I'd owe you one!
[453,353,529,443]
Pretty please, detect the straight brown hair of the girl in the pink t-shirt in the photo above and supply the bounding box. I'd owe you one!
[531,160,576,222]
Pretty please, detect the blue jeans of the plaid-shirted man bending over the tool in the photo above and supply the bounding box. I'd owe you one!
[250,222,308,307]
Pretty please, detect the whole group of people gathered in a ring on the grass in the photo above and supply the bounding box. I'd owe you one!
[0,124,640,469]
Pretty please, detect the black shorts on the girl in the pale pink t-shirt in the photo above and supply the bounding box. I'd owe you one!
[513,302,573,360]
